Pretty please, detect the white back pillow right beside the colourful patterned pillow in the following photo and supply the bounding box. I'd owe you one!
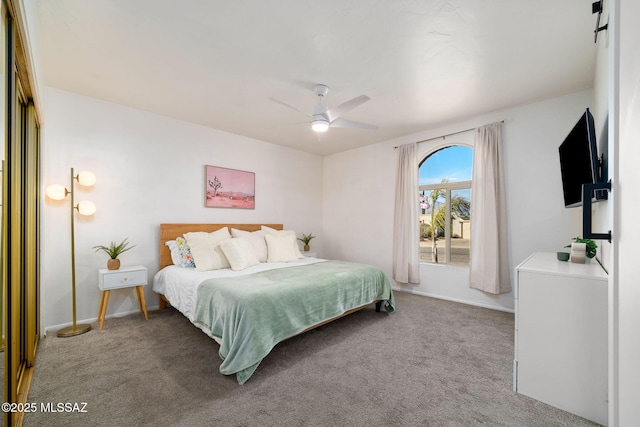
[184,227,231,271]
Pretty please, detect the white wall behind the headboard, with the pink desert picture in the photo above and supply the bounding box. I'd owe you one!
[41,88,324,334]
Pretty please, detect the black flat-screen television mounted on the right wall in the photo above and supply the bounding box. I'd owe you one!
[558,108,607,208]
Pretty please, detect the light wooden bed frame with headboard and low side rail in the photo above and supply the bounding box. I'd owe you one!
[158,224,382,314]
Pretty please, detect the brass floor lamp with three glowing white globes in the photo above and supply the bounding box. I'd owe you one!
[46,168,96,337]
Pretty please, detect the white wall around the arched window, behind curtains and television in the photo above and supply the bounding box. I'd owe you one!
[323,91,592,310]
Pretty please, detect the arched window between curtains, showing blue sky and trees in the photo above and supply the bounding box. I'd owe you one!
[418,145,473,265]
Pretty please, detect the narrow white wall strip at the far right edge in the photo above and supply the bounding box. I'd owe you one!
[612,0,640,426]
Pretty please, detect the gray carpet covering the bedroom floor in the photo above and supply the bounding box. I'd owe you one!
[24,292,595,427]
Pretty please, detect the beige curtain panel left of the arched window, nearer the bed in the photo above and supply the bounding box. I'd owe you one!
[393,143,420,284]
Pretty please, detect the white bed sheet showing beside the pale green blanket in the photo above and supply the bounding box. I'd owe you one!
[153,258,326,323]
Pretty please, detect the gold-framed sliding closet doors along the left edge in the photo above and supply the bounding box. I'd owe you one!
[1,2,40,425]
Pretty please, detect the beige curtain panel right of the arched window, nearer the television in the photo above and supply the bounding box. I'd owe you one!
[469,123,511,294]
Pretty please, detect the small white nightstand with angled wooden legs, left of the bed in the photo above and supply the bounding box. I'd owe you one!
[98,265,149,330]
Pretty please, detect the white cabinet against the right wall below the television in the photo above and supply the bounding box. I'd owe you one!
[513,252,608,425]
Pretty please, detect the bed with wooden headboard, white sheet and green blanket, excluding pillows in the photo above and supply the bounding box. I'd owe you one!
[153,224,395,384]
